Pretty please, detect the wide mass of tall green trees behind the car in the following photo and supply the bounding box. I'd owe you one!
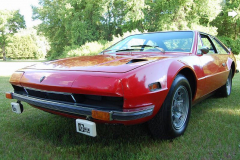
[33,0,240,59]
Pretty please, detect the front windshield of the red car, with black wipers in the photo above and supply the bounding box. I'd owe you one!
[107,31,193,52]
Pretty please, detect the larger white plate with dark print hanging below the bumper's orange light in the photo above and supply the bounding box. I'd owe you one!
[76,119,97,137]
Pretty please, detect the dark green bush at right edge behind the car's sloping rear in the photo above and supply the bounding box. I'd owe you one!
[218,36,240,55]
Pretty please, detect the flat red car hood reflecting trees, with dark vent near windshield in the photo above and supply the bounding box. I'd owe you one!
[25,53,171,73]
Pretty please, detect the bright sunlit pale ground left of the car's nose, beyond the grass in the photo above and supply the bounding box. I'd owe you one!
[0,62,40,76]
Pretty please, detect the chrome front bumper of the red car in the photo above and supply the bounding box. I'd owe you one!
[11,93,154,121]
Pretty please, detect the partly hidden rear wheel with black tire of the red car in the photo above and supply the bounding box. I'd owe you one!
[217,70,232,97]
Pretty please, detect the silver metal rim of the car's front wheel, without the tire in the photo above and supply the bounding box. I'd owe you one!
[171,86,189,130]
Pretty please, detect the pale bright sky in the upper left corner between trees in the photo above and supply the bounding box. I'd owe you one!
[0,0,41,28]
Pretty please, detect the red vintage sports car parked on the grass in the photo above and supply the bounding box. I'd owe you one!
[6,31,236,139]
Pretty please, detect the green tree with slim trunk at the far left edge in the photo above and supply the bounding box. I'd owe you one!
[0,10,26,61]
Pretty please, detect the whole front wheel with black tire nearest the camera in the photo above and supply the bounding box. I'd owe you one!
[148,74,192,139]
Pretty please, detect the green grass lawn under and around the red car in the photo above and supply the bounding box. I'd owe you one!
[0,74,240,160]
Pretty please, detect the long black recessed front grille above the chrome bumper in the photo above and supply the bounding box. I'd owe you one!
[13,85,123,110]
